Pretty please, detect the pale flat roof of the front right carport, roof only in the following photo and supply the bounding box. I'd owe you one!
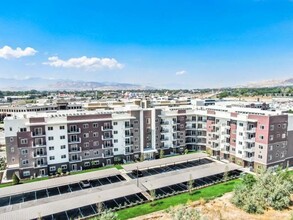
[142,163,241,190]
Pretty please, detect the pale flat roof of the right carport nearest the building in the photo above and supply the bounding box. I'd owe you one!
[122,153,208,172]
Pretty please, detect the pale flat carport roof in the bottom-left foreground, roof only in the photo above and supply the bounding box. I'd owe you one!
[0,184,142,220]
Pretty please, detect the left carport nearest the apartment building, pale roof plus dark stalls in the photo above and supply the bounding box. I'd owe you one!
[0,169,125,207]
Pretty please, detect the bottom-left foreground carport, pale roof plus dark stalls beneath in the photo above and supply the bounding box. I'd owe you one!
[0,184,146,220]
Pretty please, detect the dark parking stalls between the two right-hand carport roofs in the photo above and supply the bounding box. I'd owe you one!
[127,158,213,179]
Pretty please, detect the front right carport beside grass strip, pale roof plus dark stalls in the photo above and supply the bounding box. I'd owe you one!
[142,163,242,198]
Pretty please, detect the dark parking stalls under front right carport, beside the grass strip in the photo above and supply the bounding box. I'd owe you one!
[148,170,242,198]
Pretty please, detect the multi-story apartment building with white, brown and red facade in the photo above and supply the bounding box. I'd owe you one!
[4,105,293,178]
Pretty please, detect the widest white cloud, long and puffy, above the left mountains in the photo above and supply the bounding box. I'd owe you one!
[43,56,124,70]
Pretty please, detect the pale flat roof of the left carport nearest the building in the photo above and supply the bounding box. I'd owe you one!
[0,168,120,197]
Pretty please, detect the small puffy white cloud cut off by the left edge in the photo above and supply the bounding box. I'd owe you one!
[0,46,37,59]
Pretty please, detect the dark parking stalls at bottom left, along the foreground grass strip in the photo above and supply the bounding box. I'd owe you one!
[35,193,147,220]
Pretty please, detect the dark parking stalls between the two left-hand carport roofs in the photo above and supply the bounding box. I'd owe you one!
[0,175,125,207]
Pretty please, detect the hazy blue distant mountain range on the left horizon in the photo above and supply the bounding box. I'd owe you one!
[0,77,153,91]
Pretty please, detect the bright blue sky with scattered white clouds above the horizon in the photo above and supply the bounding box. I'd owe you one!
[0,0,293,89]
